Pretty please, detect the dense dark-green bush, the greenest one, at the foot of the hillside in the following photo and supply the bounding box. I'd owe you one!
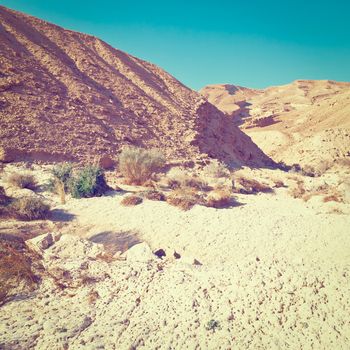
[68,165,109,198]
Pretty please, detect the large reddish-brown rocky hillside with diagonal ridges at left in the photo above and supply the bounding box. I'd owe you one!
[0,6,269,164]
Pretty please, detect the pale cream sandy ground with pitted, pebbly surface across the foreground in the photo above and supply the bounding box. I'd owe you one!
[0,166,350,349]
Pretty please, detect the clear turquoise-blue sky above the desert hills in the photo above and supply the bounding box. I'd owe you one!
[0,0,350,90]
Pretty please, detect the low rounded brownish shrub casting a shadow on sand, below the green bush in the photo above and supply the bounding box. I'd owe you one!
[8,196,50,220]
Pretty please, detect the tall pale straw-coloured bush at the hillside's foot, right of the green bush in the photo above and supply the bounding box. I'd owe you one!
[119,147,165,185]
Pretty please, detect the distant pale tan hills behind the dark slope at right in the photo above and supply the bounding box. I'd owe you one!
[201,80,350,164]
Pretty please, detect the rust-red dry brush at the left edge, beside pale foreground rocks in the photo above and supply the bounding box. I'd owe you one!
[0,241,40,305]
